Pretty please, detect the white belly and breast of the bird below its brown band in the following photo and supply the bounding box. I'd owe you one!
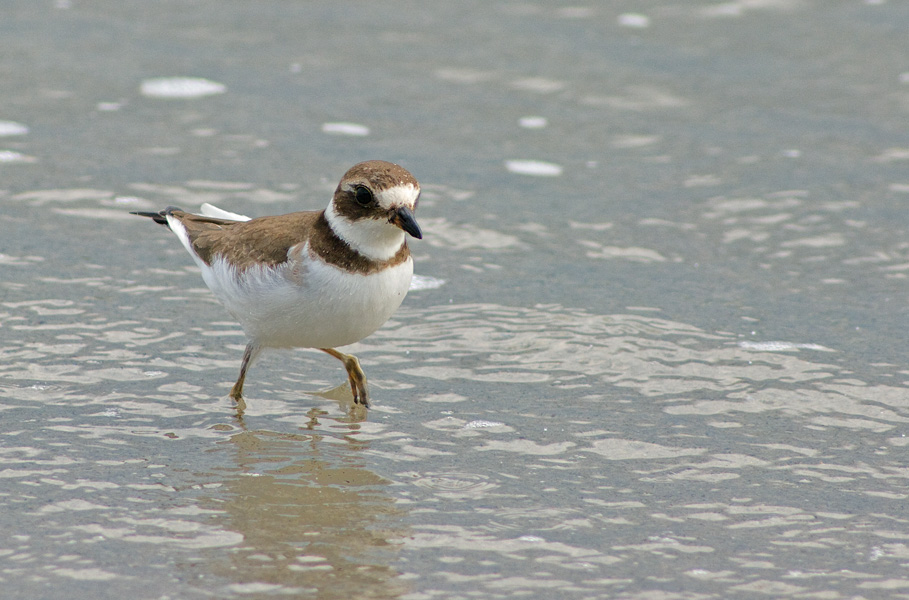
[203,258,413,348]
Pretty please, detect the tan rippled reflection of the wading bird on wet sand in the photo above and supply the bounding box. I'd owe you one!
[200,420,411,600]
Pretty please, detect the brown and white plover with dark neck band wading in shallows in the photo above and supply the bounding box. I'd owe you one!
[132,160,423,407]
